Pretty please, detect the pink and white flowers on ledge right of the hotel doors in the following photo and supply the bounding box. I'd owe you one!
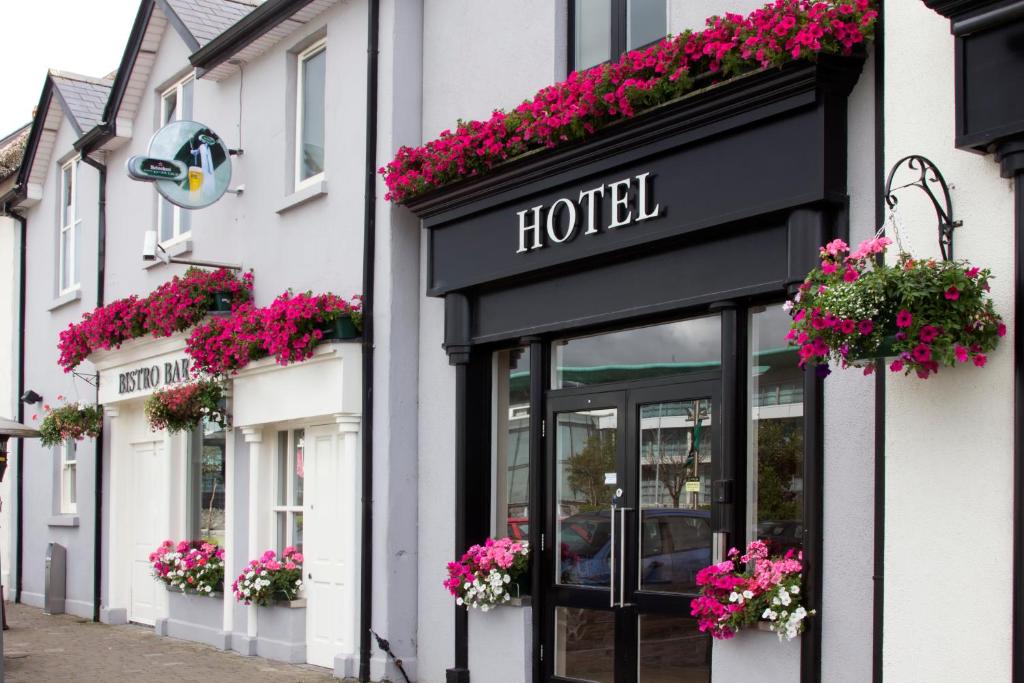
[690,541,815,640]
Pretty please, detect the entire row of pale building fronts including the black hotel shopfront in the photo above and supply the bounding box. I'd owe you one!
[0,0,1024,683]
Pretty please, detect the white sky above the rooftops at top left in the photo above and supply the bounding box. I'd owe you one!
[0,0,139,137]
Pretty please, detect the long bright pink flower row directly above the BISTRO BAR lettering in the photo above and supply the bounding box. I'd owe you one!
[57,268,253,373]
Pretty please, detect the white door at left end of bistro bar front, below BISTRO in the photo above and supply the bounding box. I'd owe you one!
[129,441,164,626]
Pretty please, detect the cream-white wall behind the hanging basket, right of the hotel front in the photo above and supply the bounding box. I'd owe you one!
[884,2,1014,683]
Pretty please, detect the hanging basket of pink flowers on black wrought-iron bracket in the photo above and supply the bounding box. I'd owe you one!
[784,237,1007,379]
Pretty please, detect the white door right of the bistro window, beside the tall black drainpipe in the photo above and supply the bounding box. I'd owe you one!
[302,427,355,669]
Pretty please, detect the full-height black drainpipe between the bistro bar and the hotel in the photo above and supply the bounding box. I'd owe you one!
[359,0,380,683]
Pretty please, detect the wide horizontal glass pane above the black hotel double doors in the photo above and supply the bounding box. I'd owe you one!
[552,315,722,389]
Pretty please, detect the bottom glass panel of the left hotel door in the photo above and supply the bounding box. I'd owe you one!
[555,607,615,683]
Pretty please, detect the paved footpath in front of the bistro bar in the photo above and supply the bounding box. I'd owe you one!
[3,602,339,683]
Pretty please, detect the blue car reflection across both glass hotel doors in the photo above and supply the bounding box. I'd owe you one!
[561,508,711,592]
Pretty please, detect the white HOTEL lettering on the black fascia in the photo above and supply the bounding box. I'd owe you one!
[516,171,660,254]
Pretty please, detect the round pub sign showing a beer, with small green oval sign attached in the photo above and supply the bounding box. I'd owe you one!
[128,121,231,209]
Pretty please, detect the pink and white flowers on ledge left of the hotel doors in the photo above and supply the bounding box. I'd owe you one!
[444,538,529,611]
